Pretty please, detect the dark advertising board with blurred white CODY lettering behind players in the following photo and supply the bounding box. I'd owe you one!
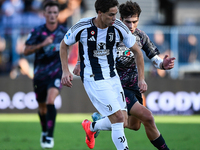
[0,76,200,115]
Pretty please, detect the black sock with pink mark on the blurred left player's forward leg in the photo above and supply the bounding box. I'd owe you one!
[47,105,57,137]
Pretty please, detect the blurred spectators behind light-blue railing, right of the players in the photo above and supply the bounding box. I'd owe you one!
[141,25,200,79]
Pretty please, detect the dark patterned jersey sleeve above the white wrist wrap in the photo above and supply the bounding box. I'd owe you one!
[134,29,160,59]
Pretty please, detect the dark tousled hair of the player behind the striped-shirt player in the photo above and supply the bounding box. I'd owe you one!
[119,1,142,19]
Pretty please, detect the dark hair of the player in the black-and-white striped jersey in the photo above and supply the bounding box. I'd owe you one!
[95,0,119,13]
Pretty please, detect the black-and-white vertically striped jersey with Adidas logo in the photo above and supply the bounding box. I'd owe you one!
[64,18,136,81]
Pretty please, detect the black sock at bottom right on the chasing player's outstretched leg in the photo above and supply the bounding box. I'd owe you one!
[151,135,169,150]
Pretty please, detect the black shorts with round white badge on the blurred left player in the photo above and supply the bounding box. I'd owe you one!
[33,76,62,103]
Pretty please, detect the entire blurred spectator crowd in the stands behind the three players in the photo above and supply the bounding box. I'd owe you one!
[0,0,200,79]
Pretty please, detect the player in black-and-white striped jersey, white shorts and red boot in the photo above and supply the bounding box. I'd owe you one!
[60,0,147,150]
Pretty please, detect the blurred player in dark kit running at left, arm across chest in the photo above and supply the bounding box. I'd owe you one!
[24,1,67,148]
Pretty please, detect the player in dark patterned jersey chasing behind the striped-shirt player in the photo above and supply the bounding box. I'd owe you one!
[83,1,175,150]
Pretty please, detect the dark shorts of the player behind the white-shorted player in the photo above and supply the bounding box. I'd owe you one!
[124,88,143,115]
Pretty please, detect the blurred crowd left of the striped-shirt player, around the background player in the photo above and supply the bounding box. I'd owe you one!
[0,0,86,79]
